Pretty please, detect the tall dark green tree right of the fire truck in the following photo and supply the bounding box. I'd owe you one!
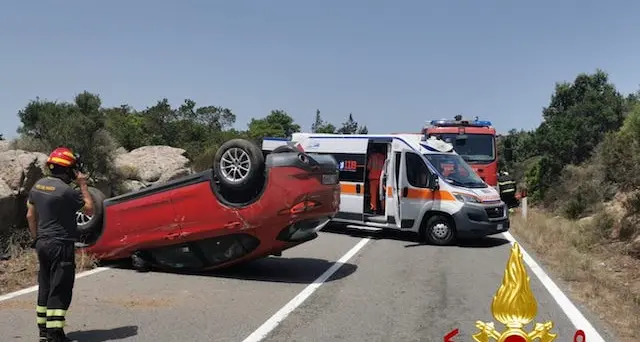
[503,70,637,200]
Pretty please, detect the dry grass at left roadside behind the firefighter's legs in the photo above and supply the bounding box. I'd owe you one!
[0,239,97,295]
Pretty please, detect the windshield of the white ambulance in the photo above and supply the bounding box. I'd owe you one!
[424,154,487,188]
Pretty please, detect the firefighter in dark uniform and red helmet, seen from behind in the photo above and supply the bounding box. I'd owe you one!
[27,147,93,342]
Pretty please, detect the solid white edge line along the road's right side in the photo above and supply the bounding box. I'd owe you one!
[502,232,604,342]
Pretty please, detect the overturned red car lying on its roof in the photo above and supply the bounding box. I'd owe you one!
[77,139,340,270]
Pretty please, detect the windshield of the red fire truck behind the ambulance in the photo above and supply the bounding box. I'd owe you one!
[431,133,495,163]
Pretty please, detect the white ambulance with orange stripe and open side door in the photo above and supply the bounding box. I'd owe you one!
[262,133,509,245]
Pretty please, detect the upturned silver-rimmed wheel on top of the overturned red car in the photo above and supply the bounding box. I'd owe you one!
[213,139,264,190]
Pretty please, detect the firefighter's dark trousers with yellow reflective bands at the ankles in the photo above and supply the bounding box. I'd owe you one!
[35,239,76,337]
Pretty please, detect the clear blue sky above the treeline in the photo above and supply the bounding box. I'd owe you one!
[0,0,640,137]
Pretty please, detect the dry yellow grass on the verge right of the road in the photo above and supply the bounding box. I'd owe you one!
[512,208,640,342]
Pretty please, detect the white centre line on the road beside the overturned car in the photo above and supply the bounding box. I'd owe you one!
[242,238,371,342]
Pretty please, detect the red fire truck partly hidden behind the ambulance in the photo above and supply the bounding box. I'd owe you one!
[421,116,498,187]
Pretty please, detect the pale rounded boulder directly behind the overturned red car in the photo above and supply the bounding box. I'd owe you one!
[114,146,189,182]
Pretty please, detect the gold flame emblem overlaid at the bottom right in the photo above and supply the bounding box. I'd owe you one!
[473,243,558,342]
